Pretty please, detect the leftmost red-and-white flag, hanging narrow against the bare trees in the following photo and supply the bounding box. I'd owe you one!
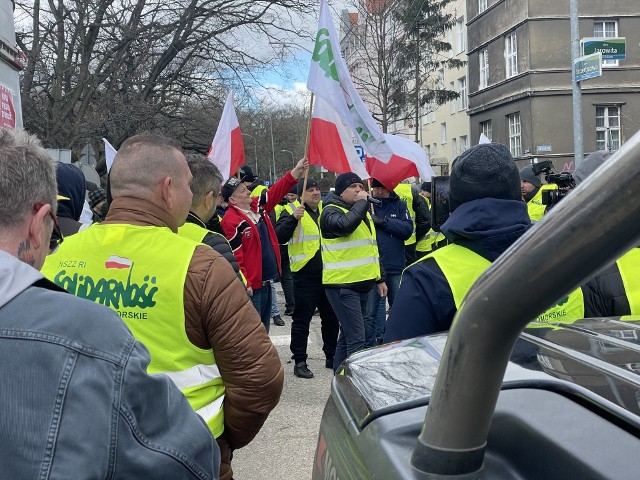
[207,92,244,182]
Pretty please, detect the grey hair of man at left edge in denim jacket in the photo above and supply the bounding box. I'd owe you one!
[0,128,58,228]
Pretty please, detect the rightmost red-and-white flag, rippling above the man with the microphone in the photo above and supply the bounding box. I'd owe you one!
[366,133,435,191]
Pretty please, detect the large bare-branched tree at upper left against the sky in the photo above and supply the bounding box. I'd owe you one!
[16,0,308,167]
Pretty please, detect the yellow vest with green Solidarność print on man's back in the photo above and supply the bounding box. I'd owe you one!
[42,224,225,437]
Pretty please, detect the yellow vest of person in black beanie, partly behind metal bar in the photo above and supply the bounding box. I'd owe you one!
[416,244,584,322]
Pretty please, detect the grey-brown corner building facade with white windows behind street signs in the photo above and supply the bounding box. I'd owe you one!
[466,0,640,171]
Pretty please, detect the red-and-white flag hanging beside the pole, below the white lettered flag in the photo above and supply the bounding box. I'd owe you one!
[309,97,369,180]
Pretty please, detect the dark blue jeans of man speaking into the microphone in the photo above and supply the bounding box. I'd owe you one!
[326,288,369,372]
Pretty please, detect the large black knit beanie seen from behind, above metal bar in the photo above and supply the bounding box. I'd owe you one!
[449,143,522,211]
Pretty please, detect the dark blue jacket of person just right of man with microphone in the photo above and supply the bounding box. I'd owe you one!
[373,192,413,275]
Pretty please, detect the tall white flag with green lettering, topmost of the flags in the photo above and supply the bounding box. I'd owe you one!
[307,0,393,162]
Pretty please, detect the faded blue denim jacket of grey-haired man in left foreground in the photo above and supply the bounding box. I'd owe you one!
[0,251,220,480]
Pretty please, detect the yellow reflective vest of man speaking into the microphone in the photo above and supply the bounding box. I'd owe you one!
[321,205,380,285]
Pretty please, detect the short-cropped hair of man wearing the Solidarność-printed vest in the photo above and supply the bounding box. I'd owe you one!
[109,133,183,199]
